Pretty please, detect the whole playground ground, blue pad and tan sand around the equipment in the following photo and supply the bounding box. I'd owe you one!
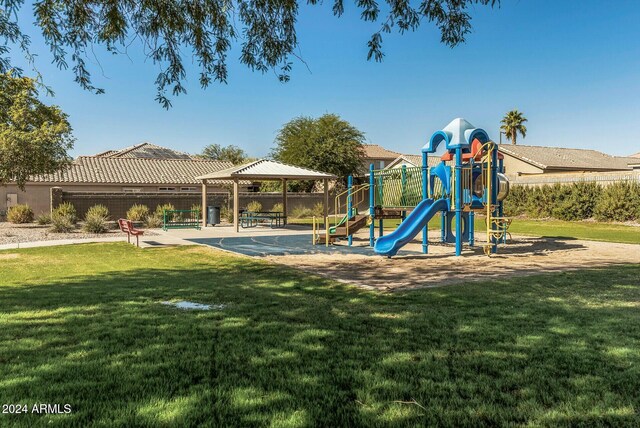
[162,227,640,291]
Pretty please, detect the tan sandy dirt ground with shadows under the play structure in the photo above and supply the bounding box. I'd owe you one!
[267,234,640,291]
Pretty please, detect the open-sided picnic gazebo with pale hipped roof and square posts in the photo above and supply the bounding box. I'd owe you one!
[196,159,337,232]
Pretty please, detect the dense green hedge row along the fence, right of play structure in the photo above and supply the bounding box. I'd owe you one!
[504,181,640,221]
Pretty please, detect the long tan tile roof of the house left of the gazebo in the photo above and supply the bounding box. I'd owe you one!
[30,156,232,184]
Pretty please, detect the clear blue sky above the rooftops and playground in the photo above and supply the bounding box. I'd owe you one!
[14,0,640,156]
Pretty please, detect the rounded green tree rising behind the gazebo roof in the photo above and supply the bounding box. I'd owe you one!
[271,114,365,191]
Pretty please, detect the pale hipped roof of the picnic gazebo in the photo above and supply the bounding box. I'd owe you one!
[197,159,336,180]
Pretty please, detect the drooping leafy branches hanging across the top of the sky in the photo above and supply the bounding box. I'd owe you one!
[0,0,500,108]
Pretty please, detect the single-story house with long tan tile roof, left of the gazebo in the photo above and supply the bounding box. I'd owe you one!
[0,143,232,215]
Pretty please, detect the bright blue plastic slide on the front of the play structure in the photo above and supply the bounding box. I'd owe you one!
[373,198,449,257]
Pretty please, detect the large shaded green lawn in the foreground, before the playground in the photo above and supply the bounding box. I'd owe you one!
[0,243,640,427]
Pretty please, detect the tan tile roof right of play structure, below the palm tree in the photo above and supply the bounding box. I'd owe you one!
[499,144,629,171]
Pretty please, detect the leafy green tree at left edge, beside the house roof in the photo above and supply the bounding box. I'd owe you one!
[0,73,74,189]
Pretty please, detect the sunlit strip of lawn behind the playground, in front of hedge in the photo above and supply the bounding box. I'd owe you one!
[293,216,640,244]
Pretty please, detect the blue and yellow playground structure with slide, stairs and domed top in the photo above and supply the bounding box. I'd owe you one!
[313,118,511,257]
